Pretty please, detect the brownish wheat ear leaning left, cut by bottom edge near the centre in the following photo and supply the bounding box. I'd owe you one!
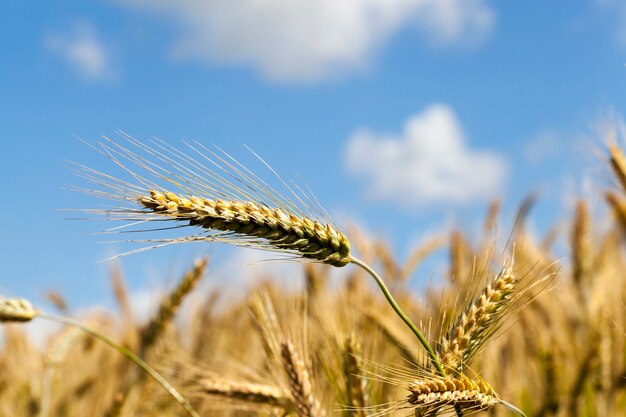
[280,341,325,417]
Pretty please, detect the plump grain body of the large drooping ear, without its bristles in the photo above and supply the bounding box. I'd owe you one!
[139,190,350,266]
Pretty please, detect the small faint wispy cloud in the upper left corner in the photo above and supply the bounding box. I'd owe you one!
[44,23,113,80]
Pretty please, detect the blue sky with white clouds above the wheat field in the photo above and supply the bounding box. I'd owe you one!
[0,0,626,306]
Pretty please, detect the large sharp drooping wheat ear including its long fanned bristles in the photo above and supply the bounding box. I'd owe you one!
[75,137,351,266]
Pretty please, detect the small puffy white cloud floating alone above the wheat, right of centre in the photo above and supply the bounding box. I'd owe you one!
[346,104,507,207]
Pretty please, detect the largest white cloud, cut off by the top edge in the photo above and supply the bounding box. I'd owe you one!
[123,0,495,82]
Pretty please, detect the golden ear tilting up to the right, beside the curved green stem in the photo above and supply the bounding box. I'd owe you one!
[438,268,516,372]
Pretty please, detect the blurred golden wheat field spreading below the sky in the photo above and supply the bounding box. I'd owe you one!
[0,137,626,417]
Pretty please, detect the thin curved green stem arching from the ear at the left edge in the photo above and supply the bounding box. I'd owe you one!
[39,312,200,417]
